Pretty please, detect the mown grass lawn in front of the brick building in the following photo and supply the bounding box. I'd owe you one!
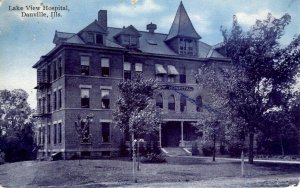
[0,159,300,187]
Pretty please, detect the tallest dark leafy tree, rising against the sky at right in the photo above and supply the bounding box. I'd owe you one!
[221,13,299,163]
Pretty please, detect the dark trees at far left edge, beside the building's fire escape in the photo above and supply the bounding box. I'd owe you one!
[0,89,35,162]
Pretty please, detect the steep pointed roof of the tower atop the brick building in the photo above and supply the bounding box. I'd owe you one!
[166,1,201,41]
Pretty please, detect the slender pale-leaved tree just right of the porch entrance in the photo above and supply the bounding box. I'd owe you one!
[194,53,241,161]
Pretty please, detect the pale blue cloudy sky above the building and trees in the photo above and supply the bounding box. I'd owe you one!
[0,0,300,108]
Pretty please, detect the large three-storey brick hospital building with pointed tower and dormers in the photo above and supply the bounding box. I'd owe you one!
[33,3,229,158]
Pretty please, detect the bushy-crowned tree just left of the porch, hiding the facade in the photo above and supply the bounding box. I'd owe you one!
[113,75,160,150]
